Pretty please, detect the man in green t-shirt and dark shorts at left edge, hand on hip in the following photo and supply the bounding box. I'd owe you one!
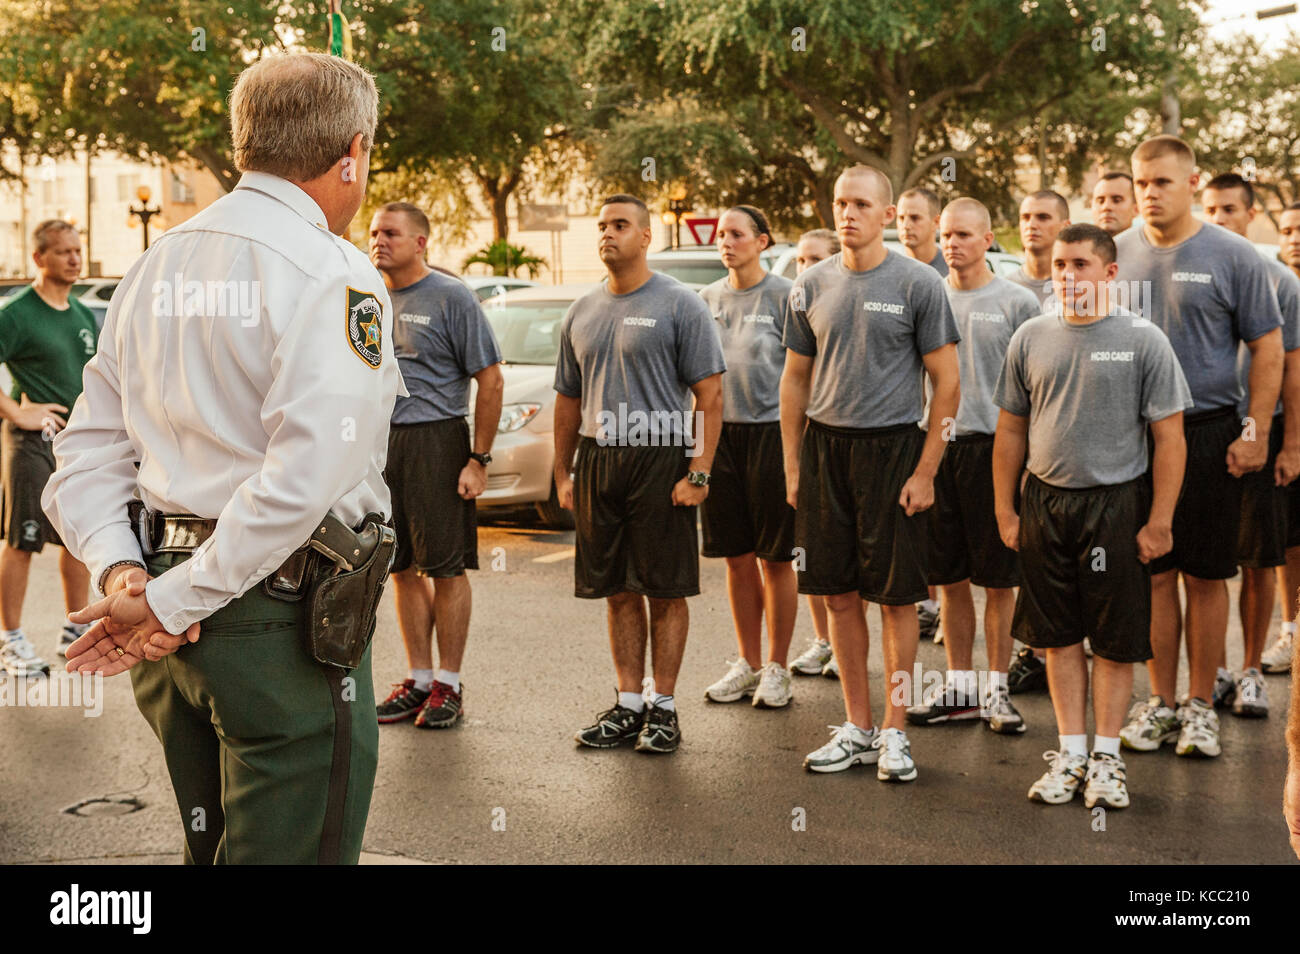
[0,218,98,676]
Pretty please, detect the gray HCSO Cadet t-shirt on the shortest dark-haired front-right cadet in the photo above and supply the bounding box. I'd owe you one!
[996,308,1192,487]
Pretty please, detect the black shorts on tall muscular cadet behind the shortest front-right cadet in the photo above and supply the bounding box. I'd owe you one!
[1147,407,1242,580]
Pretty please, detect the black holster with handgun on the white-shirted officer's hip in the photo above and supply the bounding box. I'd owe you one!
[297,513,397,669]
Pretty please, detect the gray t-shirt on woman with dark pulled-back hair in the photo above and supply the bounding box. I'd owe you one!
[699,273,793,424]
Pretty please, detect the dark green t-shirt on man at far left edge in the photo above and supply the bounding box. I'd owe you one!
[0,286,99,411]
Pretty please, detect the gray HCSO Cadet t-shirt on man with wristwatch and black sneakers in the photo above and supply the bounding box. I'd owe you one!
[555,272,727,446]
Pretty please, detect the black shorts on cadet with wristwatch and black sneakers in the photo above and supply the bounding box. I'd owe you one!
[573,437,712,599]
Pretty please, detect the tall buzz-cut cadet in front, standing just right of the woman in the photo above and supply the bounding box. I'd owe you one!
[781,166,959,781]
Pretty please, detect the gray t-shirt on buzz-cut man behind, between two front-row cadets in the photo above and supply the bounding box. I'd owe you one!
[920,277,1039,437]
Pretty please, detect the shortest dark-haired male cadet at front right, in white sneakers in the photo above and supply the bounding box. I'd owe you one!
[993,225,1192,808]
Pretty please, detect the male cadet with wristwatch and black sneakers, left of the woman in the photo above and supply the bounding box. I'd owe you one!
[555,194,727,753]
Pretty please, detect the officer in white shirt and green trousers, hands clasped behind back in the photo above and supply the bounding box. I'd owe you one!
[43,53,404,864]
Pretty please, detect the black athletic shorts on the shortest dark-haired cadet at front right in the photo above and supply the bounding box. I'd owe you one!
[1011,474,1151,663]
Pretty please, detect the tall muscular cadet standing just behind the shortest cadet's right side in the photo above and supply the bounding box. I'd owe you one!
[1115,135,1283,758]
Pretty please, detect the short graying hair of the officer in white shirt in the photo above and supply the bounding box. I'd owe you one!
[230,53,380,182]
